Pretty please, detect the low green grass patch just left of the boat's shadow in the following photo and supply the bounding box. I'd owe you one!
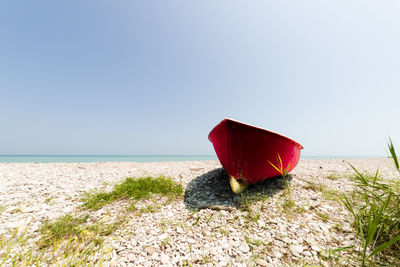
[83,176,183,210]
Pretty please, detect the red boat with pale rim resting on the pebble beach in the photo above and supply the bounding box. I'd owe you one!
[208,119,303,193]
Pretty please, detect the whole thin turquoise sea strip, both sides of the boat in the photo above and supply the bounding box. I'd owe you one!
[0,155,381,163]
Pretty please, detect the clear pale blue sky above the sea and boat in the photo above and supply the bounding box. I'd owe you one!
[0,0,400,156]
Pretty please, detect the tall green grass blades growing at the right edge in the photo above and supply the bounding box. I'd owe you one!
[342,139,400,266]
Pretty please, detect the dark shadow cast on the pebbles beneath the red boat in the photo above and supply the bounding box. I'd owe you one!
[184,168,292,209]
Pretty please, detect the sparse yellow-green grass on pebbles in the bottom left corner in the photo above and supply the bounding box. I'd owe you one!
[0,215,114,266]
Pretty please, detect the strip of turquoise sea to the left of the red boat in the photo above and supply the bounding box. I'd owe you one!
[0,155,217,163]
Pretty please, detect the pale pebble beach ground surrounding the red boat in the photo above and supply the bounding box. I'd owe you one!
[0,159,398,266]
